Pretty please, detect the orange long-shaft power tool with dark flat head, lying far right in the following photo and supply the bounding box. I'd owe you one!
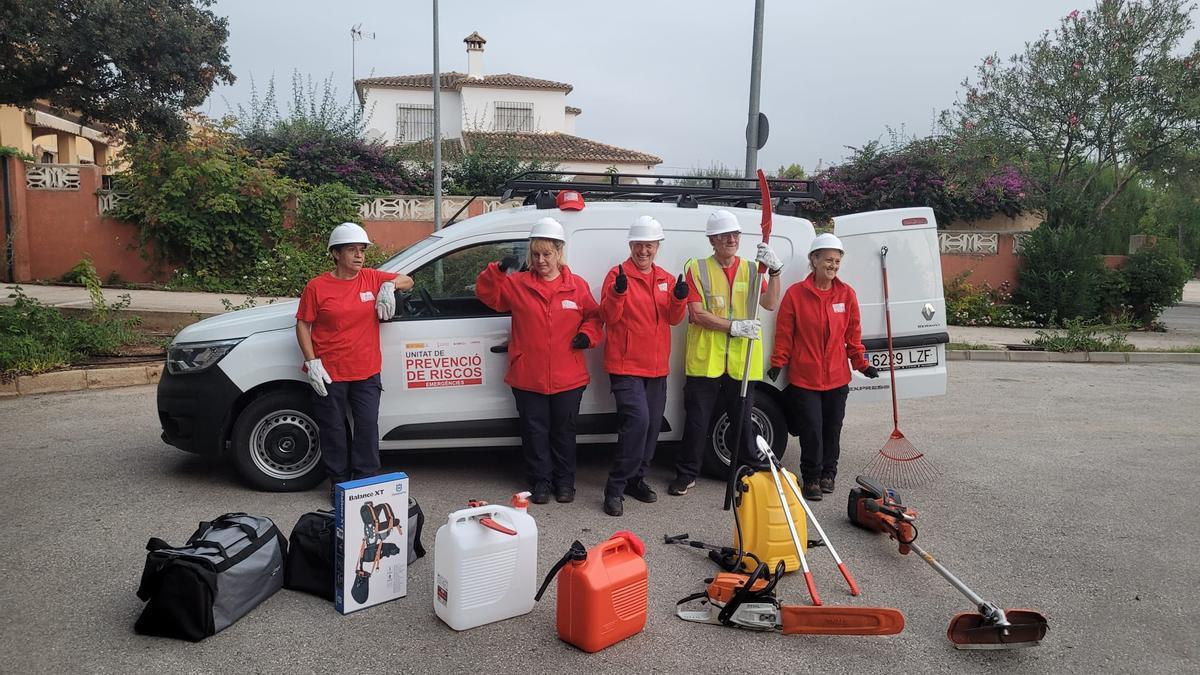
[846,476,1048,650]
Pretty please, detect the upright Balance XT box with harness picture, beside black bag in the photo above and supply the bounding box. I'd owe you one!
[334,472,408,614]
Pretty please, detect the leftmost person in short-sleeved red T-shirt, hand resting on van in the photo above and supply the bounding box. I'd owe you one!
[296,222,413,501]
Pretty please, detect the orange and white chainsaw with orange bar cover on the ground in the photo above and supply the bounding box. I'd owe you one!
[676,561,904,635]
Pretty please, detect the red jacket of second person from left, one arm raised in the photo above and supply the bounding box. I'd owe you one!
[475,263,601,394]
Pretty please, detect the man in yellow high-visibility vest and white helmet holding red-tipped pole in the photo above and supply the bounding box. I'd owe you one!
[667,209,784,496]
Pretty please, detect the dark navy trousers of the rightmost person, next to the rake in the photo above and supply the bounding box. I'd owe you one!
[786,384,850,483]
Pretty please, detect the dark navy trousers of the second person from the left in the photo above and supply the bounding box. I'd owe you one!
[512,387,584,491]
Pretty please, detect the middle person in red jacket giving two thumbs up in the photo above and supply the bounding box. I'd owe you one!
[600,216,688,515]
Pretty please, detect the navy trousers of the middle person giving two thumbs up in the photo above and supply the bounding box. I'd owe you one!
[604,375,667,497]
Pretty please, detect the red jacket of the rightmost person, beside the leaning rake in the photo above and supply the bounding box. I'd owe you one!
[770,274,869,392]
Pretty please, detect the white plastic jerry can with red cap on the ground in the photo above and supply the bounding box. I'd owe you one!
[433,492,538,631]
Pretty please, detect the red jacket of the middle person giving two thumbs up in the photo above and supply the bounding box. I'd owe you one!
[600,259,688,377]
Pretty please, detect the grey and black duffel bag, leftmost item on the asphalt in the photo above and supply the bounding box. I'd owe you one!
[133,513,288,641]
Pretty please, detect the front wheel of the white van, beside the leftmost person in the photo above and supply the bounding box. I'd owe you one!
[233,389,325,492]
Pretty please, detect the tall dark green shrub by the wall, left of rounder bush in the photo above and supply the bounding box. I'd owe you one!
[1013,225,1104,325]
